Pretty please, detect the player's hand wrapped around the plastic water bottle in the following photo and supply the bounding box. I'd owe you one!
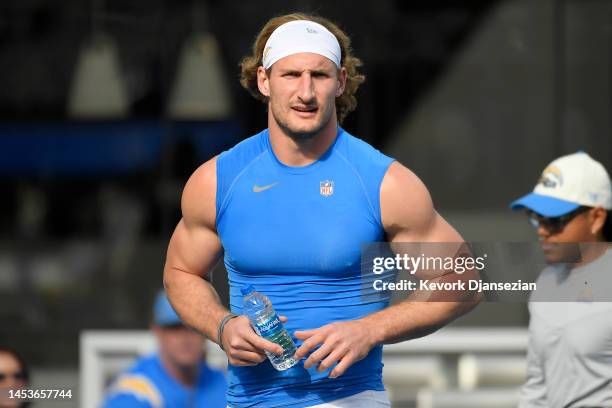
[221,316,287,366]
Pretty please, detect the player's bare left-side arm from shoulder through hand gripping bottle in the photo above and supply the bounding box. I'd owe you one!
[164,158,284,365]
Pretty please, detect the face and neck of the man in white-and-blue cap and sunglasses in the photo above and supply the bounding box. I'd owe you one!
[537,207,606,263]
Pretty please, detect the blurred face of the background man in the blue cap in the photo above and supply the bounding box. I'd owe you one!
[153,324,204,368]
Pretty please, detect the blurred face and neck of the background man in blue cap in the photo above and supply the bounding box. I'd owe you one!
[152,325,204,386]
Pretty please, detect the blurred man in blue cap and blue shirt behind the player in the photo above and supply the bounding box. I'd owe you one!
[103,291,227,408]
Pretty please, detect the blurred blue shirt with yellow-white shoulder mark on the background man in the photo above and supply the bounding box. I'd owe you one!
[103,355,227,408]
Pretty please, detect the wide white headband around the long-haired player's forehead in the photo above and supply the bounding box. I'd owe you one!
[262,20,342,69]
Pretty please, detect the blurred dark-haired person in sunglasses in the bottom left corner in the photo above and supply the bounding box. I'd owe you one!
[0,346,30,408]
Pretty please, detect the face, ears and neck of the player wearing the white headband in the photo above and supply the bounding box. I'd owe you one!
[257,52,347,166]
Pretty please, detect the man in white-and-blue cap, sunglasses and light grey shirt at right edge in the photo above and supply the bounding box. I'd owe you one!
[511,152,612,408]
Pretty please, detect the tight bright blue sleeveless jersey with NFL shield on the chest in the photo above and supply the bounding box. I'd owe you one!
[216,128,393,408]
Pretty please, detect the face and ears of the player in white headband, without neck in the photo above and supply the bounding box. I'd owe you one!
[257,52,346,139]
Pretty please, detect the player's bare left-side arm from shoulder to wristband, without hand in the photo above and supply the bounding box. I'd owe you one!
[164,158,229,341]
